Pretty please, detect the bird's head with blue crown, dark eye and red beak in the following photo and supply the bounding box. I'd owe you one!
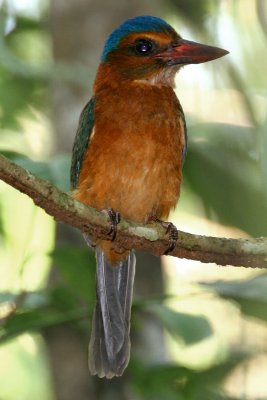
[97,16,228,86]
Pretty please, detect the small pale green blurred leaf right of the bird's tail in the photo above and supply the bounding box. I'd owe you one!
[144,304,212,344]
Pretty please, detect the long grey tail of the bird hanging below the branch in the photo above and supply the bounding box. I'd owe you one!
[89,247,135,378]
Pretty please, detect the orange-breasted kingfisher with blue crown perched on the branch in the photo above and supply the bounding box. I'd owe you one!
[71,15,228,379]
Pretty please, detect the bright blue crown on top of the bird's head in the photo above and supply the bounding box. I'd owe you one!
[101,15,174,62]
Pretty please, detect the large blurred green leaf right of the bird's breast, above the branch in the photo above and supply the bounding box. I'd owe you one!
[185,124,267,236]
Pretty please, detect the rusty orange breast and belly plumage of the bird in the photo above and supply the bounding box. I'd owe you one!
[75,82,185,222]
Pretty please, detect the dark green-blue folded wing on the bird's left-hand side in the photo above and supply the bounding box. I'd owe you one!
[70,97,96,189]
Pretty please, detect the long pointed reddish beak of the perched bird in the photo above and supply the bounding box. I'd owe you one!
[156,39,229,65]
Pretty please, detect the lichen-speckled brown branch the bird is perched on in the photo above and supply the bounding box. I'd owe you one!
[0,155,267,268]
